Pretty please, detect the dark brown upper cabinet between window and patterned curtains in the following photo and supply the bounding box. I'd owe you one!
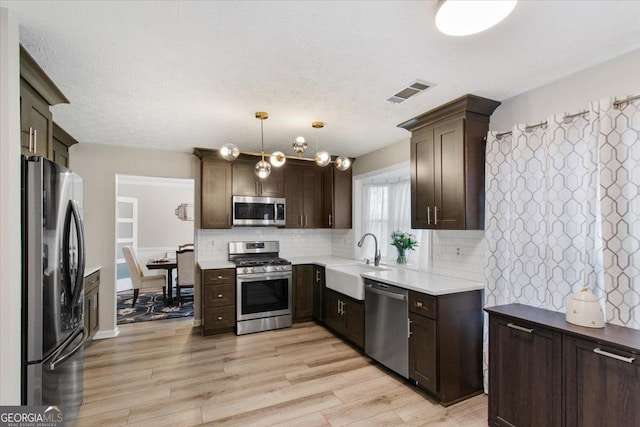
[398,95,500,230]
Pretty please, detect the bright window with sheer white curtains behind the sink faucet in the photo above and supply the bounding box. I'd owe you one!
[357,171,429,267]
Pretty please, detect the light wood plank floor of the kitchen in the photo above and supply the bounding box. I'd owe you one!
[78,319,487,427]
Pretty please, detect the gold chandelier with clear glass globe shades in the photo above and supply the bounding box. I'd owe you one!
[220,111,351,179]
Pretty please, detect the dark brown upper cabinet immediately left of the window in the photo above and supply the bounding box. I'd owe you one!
[322,165,353,229]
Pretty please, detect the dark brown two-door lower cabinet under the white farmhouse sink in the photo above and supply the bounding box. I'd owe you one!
[324,289,364,349]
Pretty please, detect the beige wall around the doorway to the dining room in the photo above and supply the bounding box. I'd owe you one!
[70,141,200,338]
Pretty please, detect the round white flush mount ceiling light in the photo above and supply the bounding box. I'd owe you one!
[436,0,517,36]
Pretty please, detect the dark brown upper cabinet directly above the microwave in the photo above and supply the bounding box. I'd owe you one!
[232,156,284,197]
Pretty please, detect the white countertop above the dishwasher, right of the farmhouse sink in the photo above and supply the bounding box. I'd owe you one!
[361,266,484,296]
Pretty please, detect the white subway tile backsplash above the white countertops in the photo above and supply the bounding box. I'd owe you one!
[196,227,485,282]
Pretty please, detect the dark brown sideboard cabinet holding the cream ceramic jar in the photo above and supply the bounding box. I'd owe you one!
[485,304,640,427]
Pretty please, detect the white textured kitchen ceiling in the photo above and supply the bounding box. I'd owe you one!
[0,0,640,156]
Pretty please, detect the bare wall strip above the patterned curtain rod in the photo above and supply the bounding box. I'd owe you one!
[490,49,640,131]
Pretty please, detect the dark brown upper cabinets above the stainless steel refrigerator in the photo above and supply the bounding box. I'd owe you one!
[20,46,69,166]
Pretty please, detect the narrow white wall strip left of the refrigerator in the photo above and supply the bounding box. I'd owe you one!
[0,8,22,405]
